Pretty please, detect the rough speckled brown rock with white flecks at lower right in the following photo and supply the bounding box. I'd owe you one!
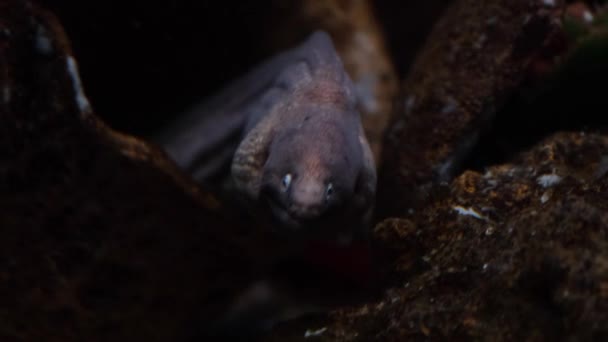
[276,133,608,341]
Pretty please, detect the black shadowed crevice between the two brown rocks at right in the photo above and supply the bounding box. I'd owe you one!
[463,48,608,171]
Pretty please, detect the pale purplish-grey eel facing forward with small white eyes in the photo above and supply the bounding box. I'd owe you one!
[158,31,376,236]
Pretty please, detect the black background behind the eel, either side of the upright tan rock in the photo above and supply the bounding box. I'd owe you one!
[40,0,449,136]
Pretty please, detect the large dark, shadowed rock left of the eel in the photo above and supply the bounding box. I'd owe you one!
[0,0,263,341]
